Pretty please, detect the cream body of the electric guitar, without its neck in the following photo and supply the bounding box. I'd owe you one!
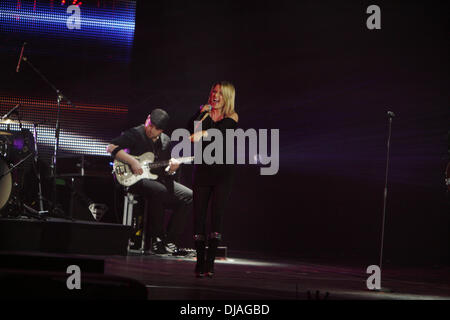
[113,152,158,187]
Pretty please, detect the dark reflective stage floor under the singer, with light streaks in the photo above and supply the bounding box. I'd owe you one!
[105,252,450,300]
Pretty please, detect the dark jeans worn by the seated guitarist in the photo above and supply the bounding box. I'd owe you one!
[130,179,192,247]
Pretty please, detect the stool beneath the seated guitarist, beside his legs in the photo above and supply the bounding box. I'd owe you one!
[122,188,148,254]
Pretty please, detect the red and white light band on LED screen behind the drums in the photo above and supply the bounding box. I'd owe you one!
[0,95,128,159]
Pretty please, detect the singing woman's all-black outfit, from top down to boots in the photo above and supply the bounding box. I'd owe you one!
[186,111,237,276]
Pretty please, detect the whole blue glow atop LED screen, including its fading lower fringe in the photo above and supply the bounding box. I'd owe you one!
[0,0,136,62]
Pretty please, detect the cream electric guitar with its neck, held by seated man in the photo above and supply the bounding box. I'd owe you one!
[113,152,194,187]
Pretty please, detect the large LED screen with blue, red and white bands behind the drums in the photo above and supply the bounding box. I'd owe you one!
[0,0,135,162]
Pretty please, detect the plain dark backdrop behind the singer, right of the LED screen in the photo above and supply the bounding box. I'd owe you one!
[130,0,450,264]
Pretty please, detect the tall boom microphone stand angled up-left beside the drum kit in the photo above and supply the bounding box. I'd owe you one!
[22,56,73,220]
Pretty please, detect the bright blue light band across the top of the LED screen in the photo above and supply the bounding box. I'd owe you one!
[0,0,136,47]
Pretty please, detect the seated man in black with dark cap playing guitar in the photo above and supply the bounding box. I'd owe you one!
[107,109,192,254]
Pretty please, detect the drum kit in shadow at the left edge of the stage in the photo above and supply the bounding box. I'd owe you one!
[0,111,111,221]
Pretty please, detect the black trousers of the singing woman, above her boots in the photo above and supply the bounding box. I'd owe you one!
[193,179,232,236]
